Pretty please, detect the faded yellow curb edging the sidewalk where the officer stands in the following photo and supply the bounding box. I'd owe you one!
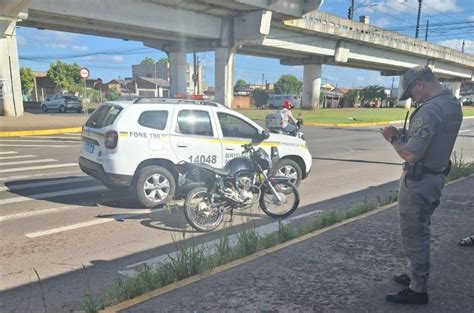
[100,174,474,313]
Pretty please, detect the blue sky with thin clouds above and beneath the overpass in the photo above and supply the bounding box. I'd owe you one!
[17,0,474,88]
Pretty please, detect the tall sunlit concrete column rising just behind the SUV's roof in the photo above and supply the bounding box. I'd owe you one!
[215,48,234,108]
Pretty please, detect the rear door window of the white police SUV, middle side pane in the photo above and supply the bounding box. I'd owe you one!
[176,110,214,136]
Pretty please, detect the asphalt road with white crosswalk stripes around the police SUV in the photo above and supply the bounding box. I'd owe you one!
[0,120,474,312]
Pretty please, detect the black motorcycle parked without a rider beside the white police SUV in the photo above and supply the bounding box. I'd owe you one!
[178,139,300,232]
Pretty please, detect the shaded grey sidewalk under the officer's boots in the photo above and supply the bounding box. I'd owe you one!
[105,176,474,313]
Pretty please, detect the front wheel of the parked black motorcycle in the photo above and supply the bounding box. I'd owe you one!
[259,181,300,218]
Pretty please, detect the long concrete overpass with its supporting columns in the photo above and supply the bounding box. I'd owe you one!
[0,0,474,115]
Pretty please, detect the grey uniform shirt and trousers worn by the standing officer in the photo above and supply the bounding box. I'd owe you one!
[398,89,462,292]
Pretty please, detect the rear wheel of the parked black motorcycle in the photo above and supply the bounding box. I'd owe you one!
[184,187,224,232]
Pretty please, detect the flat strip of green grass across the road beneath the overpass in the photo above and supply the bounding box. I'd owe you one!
[237,107,474,125]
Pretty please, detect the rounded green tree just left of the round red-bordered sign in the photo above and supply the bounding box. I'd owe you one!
[48,60,81,92]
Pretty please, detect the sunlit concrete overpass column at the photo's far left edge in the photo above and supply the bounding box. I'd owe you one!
[0,21,23,116]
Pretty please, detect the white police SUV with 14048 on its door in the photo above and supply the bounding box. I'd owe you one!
[79,98,312,207]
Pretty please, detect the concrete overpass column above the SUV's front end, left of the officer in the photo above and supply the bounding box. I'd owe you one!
[302,64,322,109]
